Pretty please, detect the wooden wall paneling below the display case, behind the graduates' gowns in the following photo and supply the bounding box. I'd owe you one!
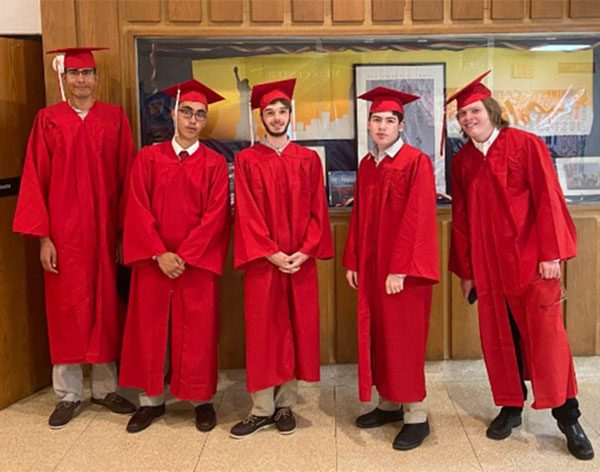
[220,205,600,367]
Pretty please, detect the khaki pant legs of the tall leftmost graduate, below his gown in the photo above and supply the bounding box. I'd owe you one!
[52,362,117,402]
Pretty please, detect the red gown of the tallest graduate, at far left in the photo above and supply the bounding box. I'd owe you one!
[13,102,134,364]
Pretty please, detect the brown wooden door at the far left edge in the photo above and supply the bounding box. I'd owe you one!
[0,38,51,408]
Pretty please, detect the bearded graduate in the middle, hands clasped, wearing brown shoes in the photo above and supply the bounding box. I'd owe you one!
[230,79,333,439]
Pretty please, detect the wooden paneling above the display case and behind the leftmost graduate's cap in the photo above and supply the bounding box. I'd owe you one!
[41,0,600,131]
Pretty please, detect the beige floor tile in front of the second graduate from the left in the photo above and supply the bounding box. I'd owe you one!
[56,393,222,472]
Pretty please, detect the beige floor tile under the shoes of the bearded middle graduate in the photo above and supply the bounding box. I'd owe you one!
[196,386,335,472]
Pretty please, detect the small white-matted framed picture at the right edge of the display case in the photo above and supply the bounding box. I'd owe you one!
[556,157,600,196]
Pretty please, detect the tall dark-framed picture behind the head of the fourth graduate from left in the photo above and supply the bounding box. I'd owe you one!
[353,63,446,193]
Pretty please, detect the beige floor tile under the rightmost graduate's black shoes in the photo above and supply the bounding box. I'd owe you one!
[446,381,600,472]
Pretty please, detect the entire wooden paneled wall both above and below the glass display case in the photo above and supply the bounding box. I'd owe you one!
[32,0,600,367]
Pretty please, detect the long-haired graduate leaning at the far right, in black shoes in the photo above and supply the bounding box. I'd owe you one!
[447,71,594,460]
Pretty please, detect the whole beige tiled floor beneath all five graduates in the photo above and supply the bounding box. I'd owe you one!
[0,357,600,472]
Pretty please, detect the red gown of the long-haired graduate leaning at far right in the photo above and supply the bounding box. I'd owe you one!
[449,128,577,408]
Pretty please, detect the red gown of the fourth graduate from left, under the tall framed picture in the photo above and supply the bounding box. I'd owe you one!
[343,144,439,403]
